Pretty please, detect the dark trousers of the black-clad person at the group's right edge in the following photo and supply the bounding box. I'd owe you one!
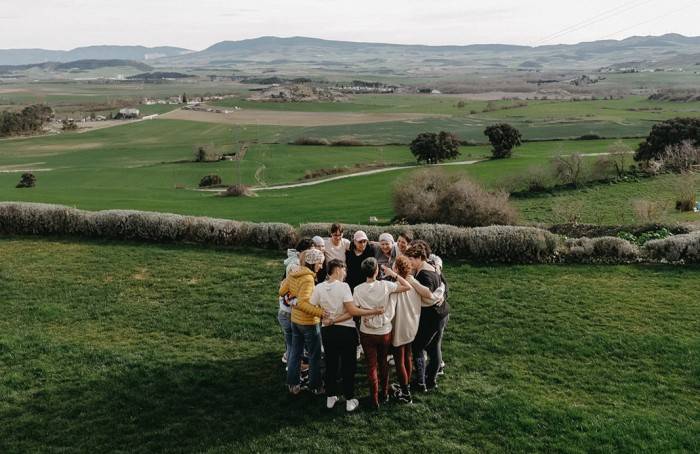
[412,308,450,386]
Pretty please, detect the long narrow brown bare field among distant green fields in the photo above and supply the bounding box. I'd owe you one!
[158,109,441,126]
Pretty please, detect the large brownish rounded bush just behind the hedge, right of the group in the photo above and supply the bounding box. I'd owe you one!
[438,178,518,227]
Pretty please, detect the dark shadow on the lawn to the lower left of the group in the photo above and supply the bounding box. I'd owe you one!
[0,353,345,452]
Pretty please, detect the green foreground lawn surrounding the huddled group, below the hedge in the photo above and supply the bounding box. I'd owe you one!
[0,238,700,453]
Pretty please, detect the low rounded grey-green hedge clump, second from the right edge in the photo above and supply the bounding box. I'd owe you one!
[564,236,639,263]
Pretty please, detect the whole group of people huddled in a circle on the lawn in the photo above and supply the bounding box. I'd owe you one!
[278,224,449,412]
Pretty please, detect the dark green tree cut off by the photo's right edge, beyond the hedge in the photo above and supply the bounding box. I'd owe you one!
[634,118,700,161]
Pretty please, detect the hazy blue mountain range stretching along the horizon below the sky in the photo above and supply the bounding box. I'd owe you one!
[0,34,700,70]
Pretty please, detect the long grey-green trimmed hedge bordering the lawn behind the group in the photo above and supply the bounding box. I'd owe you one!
[0,202,700,264]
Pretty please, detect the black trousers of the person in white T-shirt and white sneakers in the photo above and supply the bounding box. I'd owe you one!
[321,325,357,400]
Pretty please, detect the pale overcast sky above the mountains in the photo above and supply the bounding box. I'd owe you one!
[0,0,700,50]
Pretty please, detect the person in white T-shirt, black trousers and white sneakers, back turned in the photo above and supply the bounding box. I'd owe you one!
[311,259,384,412]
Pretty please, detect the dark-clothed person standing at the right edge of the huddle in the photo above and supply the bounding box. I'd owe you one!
[405,245,449,391]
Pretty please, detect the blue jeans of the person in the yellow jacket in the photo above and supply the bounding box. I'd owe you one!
[287,322,321,389]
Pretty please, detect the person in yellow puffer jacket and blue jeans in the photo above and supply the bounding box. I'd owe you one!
[279,248,328,394]
